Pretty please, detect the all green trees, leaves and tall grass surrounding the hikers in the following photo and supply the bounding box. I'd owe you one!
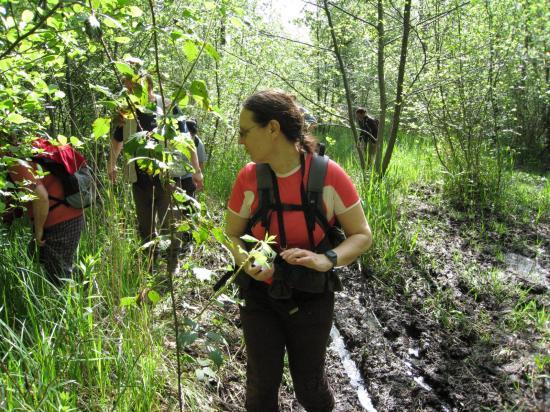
[0,0,550,410]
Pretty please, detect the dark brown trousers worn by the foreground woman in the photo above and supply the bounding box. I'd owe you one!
[240,281,334,412]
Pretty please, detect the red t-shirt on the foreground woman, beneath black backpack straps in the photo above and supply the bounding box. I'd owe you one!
[228,154,360,249]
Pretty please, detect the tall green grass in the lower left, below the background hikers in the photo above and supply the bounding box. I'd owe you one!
[0,174,211,411]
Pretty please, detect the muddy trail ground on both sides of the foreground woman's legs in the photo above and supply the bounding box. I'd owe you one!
[158,188,550,412]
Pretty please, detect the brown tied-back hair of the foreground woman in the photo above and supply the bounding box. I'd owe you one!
[243,90,317,153]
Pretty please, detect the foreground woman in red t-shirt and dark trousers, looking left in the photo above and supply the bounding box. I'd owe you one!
[226,90,372,412]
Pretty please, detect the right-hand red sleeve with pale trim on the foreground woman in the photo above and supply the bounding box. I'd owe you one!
[323,160,361,215]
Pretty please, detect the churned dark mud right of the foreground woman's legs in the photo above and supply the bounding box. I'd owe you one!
[336,189,550,411]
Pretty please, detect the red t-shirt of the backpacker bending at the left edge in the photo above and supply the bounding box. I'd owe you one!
[9,162,83,228]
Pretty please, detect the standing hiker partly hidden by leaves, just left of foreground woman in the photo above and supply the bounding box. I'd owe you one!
[107,74,203,243]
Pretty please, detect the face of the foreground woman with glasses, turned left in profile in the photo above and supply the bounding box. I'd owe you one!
[239,109,272,163]
